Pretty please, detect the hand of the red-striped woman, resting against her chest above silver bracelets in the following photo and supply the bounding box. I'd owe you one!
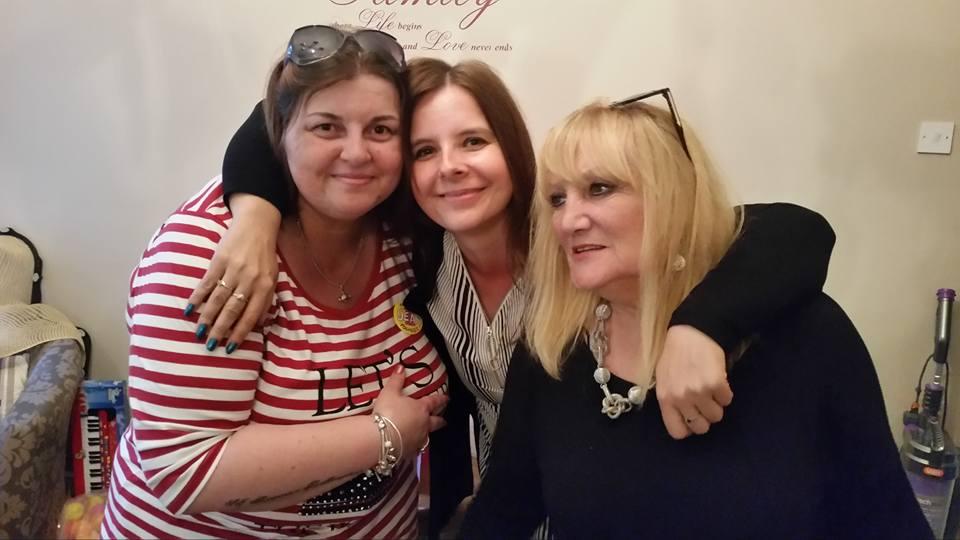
[373,364,449,458]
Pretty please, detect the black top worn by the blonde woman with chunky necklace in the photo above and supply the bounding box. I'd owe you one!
[461,295,932,539]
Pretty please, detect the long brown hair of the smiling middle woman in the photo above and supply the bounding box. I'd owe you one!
[407,58,537,274]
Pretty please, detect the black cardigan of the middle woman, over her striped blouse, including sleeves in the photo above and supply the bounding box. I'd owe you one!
[223,104,835,536]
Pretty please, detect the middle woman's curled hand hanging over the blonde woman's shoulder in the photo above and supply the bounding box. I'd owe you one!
[656,325,733,439]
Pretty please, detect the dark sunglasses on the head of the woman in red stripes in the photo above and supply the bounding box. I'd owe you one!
[287,25,407,71]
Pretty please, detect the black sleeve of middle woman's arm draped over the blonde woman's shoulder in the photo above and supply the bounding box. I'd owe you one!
[670,203,836,353]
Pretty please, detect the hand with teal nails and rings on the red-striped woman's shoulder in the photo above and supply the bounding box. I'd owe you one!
[184,193,281,353]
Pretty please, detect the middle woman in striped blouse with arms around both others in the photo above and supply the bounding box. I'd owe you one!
[192,58,834,532]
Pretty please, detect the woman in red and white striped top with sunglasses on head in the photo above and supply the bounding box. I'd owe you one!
[101,27,448,538]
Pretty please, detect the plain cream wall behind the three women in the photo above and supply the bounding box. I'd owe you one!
[0,0,960,433]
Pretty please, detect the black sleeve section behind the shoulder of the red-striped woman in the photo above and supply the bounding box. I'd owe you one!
[223,101,290,214]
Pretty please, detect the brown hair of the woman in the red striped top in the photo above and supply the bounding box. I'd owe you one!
[263,35,409,226]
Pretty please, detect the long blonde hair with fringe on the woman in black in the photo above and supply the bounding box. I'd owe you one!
[525,99,740,384]
